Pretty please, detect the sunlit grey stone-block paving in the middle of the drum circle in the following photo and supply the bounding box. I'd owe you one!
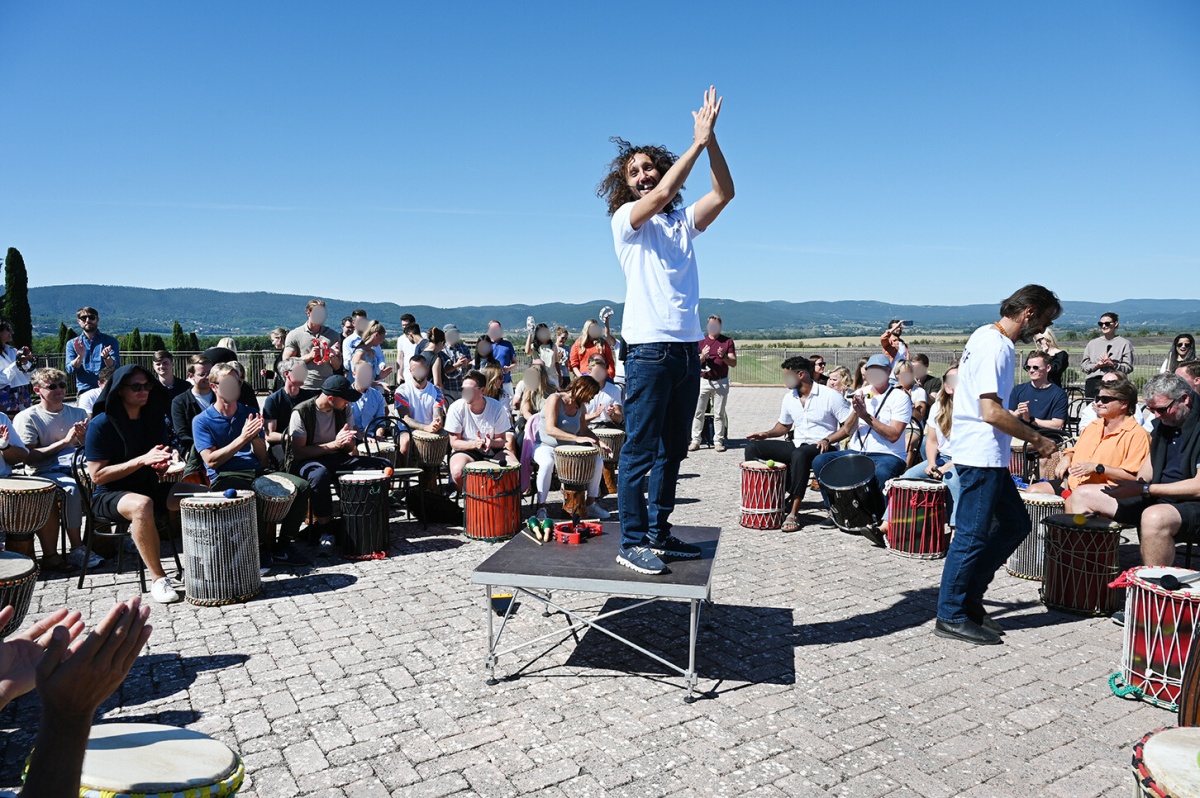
[0,389,1174,798]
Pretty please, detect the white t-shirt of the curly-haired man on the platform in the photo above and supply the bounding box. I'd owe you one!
[612,203,704,344]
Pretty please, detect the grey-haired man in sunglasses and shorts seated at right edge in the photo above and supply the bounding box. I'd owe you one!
[1066,374,1200,573]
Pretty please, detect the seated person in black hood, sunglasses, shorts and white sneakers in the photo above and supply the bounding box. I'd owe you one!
[84,364,206,604]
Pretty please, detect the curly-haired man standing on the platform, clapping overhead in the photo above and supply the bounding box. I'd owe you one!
[598,86,733,574]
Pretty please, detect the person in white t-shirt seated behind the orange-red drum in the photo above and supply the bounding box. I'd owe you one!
[445,371,521,491]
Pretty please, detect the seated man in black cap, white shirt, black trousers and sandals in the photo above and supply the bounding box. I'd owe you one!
[745,358,850,532]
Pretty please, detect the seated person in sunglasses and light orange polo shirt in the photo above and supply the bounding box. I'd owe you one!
[1028,374,1150,496]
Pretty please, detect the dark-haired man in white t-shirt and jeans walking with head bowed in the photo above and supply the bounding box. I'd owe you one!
[934,286,1062,646]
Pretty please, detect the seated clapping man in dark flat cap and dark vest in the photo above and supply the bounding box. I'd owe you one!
[284,374,389,551]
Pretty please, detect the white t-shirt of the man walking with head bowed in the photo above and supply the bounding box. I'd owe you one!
[954,324,1016,468]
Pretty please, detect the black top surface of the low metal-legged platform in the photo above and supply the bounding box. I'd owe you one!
[470,523,721,599]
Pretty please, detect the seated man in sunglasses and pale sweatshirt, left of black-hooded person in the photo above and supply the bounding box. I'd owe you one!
[12,368,104,568]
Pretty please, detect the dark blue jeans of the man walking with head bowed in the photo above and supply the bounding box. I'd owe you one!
[937,466,1031,624]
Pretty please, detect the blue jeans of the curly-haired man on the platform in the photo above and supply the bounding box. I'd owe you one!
[617,343,700,546]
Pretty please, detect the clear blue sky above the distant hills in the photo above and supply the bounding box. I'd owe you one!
[0,0,1200,305]
